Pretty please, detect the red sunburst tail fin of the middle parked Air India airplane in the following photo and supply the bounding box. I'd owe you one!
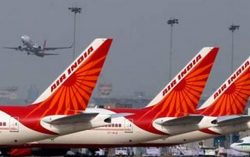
[142,47,219,119]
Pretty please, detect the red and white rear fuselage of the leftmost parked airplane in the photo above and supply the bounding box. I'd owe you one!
[0,106,109,147]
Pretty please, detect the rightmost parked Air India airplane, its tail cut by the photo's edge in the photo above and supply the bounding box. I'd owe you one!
[139,57,250,146]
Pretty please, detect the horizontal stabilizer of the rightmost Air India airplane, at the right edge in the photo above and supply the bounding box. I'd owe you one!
[216,115,250,126]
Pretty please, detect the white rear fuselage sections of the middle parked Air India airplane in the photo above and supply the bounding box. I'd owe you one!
[29,108,216,148]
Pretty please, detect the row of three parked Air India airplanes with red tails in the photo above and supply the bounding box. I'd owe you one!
[0,39,250,155]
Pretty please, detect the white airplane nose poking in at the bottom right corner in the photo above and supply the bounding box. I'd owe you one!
[230,136,250,153]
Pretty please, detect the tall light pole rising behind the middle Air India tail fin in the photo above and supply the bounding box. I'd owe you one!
[167,18,179,81]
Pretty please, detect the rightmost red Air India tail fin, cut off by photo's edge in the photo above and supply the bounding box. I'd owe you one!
[197,57,250,116]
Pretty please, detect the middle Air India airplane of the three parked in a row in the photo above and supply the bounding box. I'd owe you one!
[7,47,219,156]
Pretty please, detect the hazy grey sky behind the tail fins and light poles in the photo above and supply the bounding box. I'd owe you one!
[0,0,250,98]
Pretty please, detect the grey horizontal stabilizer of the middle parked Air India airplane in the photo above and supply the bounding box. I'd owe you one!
[156,115,203,126]
